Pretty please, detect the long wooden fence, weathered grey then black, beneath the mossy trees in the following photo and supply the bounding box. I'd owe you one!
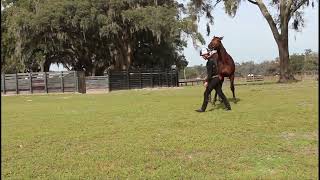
[1,69,179,94]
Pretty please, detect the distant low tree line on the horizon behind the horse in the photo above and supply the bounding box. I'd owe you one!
[179,49,319,79]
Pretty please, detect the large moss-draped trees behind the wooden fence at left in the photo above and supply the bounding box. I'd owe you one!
[1,0,205,75]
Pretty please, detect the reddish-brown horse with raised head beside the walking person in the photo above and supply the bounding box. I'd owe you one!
[208,36,236,104]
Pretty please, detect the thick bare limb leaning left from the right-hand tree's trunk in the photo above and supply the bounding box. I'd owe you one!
[256,0,280,42]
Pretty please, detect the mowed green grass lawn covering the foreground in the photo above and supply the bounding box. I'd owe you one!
[1,81,319,179]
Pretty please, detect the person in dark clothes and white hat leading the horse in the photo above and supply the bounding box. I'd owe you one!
[196,48,231,112]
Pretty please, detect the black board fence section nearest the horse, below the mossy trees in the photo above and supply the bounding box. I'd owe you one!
[109,70,179,91]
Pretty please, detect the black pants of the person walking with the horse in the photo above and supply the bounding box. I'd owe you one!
[201,77,231,111]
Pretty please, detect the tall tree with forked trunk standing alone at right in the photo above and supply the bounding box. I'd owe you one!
[192,0,315,82]
